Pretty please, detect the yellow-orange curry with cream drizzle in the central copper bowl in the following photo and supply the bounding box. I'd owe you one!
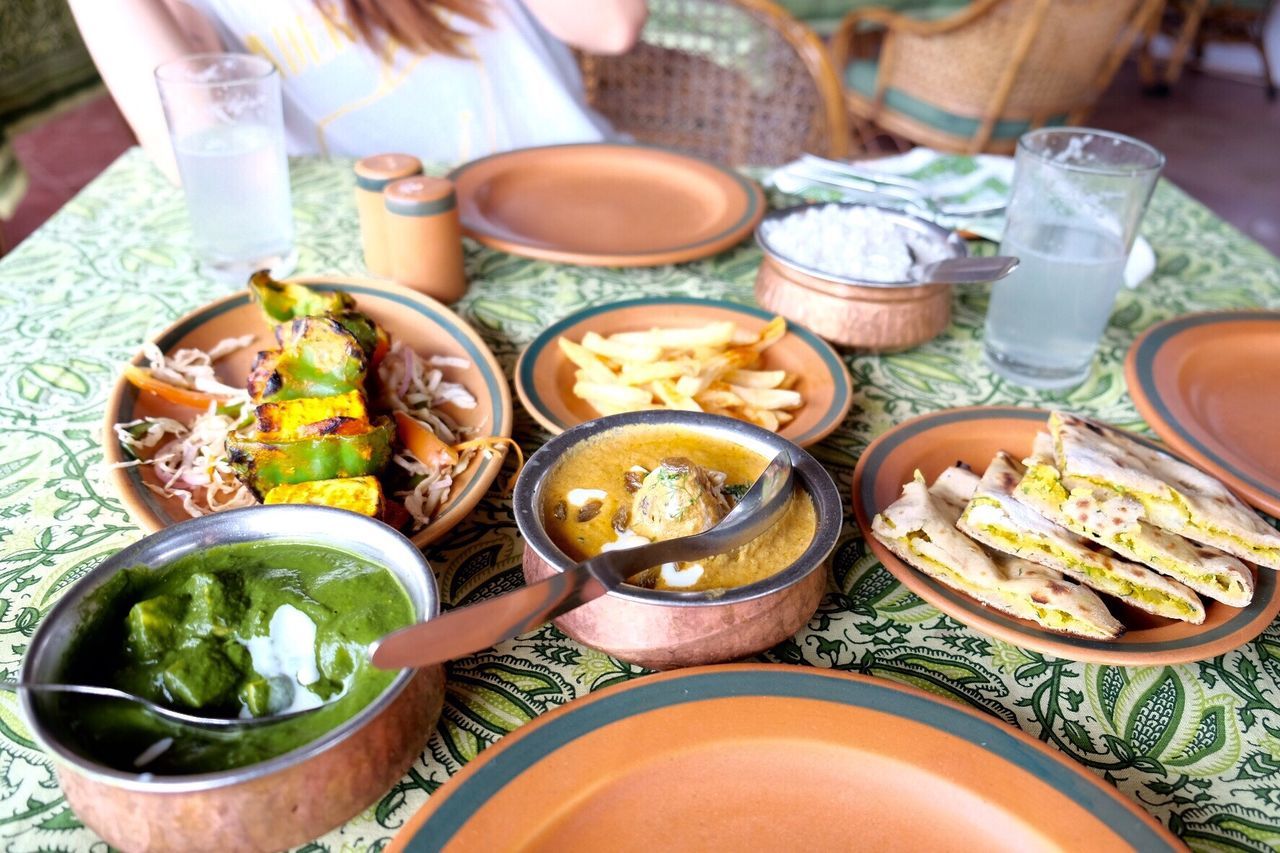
[541,425,817,592]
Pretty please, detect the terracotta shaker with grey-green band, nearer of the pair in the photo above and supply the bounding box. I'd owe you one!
[383,175,467,302]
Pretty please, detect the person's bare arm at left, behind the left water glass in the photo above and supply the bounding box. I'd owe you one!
[70,0,209,181]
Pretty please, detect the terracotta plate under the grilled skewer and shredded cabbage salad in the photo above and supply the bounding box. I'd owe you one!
[102,277,512,546]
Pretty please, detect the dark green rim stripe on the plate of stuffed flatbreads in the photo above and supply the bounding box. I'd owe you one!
[858,407,1276,653]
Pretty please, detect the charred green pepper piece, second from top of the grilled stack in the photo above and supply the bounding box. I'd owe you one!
[248,316,369,402]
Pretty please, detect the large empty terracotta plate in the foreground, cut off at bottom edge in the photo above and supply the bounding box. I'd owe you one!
[388,665,1181,853]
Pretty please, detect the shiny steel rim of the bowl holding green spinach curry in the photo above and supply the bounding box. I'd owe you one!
[18,505,440,794]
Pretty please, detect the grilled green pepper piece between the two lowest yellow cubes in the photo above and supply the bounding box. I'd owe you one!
[227,416,396,491]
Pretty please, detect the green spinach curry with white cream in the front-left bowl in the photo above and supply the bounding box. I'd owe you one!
[58,540,413,774]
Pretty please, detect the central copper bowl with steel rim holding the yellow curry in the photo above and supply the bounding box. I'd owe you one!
[513,410,844,669]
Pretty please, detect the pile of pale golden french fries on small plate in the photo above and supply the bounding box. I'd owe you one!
[558,316,804,432]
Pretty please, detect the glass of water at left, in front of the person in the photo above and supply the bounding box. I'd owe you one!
[155,54,297,283]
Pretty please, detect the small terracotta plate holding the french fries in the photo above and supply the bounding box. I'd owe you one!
[516,296,854,447]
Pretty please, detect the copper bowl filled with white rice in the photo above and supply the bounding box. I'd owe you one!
[755,202,969,352]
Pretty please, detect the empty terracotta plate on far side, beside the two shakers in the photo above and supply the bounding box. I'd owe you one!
[449,143,765,266]
